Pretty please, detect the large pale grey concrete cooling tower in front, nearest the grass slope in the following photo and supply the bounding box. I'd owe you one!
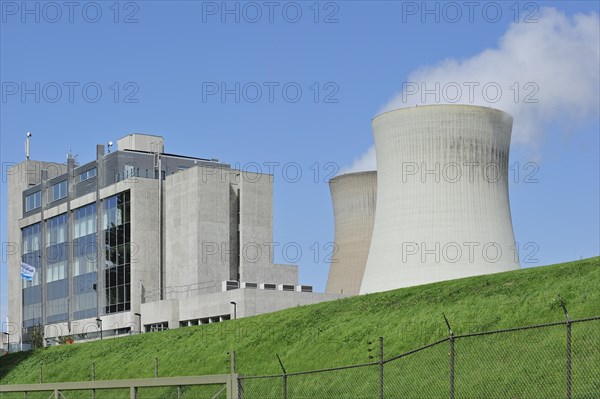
[360,105,520,294]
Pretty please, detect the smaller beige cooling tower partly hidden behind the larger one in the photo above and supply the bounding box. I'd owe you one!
[326,171,377,295]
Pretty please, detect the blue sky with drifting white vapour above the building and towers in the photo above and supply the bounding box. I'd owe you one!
[0,1,600,328]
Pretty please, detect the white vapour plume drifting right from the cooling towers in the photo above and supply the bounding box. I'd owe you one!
[345,8,600,172]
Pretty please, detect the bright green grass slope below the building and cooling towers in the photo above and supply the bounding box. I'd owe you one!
[0,257,600,398]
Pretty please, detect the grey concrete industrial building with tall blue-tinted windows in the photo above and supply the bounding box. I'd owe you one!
[7,134,339,347]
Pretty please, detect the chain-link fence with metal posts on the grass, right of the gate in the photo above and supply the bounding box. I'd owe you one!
[238,318,600,399]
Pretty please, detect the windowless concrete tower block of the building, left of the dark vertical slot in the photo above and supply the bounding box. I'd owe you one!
[164,166,236,294]
